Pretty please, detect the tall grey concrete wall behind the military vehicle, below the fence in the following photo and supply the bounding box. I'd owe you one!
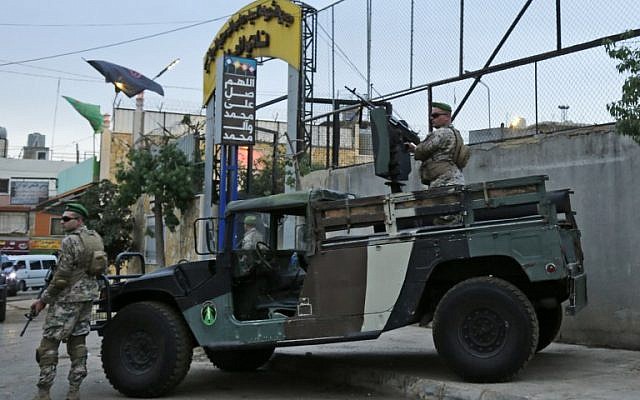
[303,125,640,350]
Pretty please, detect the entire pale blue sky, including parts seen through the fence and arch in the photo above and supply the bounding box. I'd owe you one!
[0,0,640,159]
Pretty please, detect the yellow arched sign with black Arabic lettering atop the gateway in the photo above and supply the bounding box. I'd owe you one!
[204,0,308,104]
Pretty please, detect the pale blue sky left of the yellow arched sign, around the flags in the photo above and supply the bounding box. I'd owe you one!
[0,0,338,158]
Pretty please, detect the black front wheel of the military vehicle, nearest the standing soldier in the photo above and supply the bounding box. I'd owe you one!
[102,302,193,397]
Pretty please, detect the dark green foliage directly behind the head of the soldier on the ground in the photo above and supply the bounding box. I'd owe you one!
[79,180,133,262]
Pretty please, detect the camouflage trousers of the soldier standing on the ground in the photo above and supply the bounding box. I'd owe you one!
[36,301,92,389]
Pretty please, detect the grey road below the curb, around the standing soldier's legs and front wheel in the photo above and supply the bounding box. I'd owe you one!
[0,291,392,400]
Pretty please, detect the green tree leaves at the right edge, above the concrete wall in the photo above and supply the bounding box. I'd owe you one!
[605,33,640,144]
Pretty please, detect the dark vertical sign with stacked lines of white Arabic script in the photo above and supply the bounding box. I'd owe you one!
[215,56,258,145]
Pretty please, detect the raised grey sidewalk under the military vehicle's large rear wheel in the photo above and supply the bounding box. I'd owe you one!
[270,326,640,400]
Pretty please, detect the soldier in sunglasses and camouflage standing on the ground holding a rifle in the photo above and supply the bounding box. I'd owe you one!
[31,203,102,400]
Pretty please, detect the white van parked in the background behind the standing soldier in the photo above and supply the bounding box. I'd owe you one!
[2,254,57,296]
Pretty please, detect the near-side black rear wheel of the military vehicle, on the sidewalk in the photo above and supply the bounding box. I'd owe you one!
[433,277,538,382]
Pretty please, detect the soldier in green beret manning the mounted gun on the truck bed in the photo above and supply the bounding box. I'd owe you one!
[406,103,469,188]
